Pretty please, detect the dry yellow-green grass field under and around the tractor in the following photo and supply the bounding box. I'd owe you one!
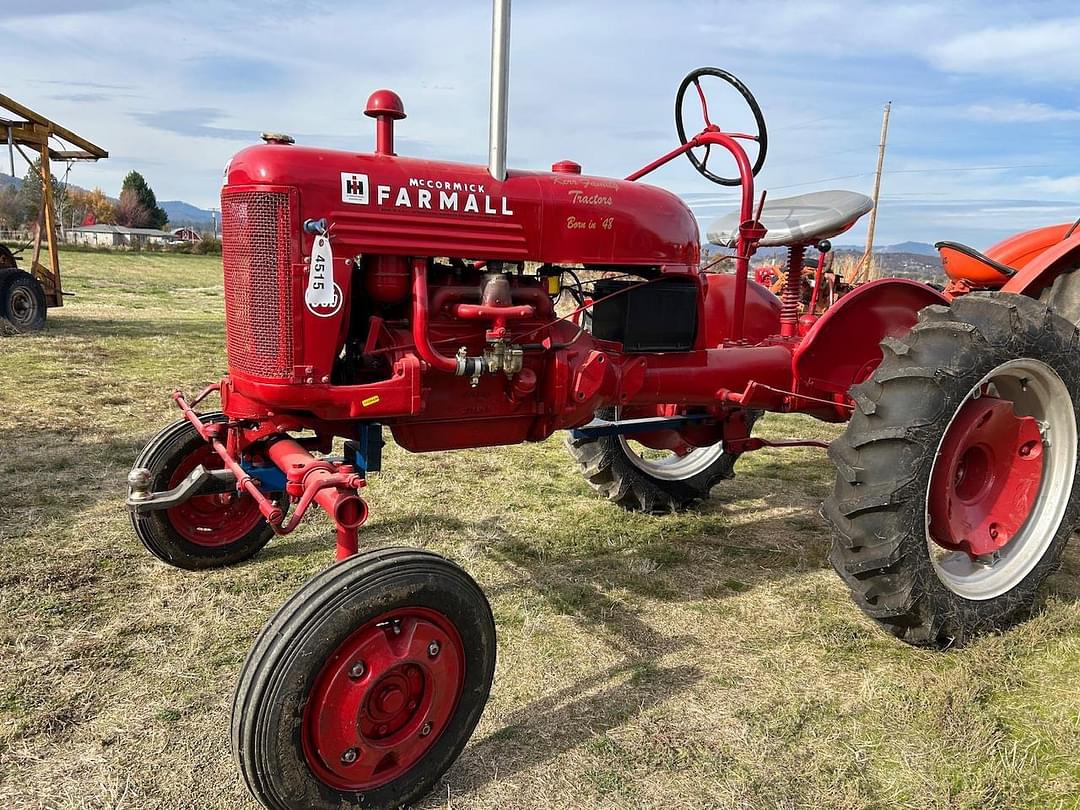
[0,253,1080,810]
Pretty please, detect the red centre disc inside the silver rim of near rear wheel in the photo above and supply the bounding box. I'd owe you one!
[927,393,1043,557]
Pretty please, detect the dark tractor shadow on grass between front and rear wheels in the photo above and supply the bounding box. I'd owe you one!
[300,499,826,795]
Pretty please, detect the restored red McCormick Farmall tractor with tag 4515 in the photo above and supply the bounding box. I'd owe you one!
[129,6,1080,810]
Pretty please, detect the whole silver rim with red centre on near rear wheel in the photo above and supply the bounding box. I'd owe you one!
[926,357,1077,600]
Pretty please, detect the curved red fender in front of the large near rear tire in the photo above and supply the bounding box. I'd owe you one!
[792,279,948,395]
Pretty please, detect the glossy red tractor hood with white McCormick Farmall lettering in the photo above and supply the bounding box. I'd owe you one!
[222,144,701,272]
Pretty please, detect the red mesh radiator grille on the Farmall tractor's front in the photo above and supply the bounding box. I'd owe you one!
[221,191,294,379]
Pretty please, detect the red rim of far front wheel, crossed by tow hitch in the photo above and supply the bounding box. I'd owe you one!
[165,444,262,548]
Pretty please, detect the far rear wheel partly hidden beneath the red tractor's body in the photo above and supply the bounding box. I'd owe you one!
[566,408,759,513]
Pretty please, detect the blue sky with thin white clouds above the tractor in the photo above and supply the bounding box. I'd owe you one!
[0,0,1080,246]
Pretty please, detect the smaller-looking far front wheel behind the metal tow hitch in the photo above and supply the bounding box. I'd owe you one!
[131,411,273,570]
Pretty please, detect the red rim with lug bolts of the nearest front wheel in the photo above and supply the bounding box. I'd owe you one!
[302,607,465,791]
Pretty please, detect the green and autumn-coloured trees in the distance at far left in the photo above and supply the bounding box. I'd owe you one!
[0,159,168,230]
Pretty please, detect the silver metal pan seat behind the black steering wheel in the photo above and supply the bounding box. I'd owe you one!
[707,191,874,247]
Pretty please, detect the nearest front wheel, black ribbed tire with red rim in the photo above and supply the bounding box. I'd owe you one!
[232,549,496,810]
